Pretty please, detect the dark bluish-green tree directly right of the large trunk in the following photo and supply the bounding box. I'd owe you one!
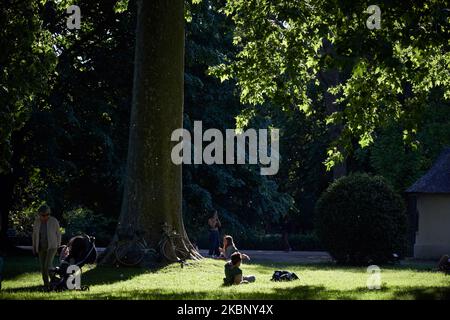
[183,0,297,242]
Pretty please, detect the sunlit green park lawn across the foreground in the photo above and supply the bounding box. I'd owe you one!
[0,257,450,299]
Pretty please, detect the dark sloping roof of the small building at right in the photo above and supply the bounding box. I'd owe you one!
[406,148,450,193]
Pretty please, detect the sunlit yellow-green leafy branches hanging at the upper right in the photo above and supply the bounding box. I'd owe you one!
[213,0,450,168]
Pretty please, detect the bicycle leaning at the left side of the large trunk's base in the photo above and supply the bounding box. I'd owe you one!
[114,230,158,267]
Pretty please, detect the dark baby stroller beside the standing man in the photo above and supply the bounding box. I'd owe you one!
[49,235,97,291]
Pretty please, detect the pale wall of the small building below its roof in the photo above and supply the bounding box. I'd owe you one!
[414,194,450,259]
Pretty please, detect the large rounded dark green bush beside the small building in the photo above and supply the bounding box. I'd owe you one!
[316,174,406,264]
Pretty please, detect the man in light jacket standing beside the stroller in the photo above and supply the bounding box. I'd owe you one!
[33,205,61,287]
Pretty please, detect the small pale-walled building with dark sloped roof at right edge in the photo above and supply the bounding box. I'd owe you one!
[406,148,450,259]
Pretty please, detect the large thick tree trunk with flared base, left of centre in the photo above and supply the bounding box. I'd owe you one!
[103,0,199,262]
